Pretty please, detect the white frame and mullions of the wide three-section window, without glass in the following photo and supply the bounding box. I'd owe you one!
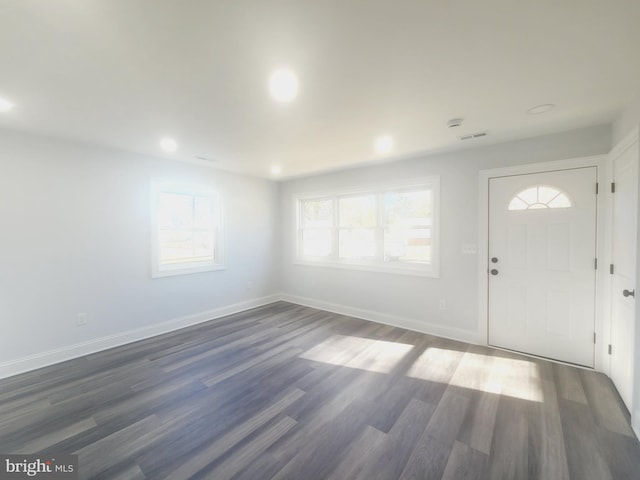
[293,175,441,278]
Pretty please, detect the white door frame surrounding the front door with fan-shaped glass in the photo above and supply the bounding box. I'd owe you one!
[478,155,611,373]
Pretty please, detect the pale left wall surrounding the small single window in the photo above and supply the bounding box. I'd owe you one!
[0,131,280,377]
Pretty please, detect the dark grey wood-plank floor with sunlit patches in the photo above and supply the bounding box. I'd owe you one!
[0,302,640,480]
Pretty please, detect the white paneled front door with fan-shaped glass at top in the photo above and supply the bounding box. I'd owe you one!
[487,167,597,367]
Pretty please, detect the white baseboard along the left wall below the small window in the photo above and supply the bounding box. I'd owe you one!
[0,295,282,378]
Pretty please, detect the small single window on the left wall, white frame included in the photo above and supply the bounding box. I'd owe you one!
[151,180,224,277]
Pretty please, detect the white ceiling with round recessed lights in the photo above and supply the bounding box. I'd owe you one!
[0,0,640,177]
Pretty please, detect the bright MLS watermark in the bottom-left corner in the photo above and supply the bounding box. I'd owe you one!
[0,455,78,480]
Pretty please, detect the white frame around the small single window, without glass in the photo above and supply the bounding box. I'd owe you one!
[149,178,226,278]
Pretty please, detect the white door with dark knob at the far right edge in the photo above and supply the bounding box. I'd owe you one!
[611,135,638,410]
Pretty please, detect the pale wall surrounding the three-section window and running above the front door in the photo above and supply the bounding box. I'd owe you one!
[280,126,611,341]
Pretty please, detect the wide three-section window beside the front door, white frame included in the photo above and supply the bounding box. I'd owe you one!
[295,177,439,277]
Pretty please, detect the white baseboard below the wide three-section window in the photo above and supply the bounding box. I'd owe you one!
[280,293,483,345]
